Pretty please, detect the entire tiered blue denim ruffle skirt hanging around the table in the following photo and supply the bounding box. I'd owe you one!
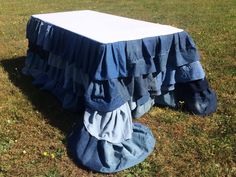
[23,17,216,173]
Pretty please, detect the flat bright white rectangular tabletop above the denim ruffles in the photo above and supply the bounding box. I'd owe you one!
[33,10,183,43]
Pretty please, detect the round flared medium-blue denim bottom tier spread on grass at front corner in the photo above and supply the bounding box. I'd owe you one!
[68,123,155,173]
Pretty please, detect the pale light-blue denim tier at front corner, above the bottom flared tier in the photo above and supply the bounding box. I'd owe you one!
[84,103,133,144]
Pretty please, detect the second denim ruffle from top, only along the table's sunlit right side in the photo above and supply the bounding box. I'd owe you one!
[86,61,205,111]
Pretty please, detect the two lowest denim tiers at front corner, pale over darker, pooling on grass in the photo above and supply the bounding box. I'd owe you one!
[68,104,155,173]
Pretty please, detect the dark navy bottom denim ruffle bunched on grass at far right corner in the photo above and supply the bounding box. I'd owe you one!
[155,78,217,116]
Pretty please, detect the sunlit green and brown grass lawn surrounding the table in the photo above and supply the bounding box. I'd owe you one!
[0,0,236,177]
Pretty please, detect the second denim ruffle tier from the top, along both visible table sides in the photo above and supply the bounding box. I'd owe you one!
[23,51,205,112]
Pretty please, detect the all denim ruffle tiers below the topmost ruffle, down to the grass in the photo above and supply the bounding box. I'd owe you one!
[23,50,216,173]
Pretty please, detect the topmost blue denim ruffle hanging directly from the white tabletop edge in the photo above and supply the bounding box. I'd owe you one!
[26,17,199,81]
